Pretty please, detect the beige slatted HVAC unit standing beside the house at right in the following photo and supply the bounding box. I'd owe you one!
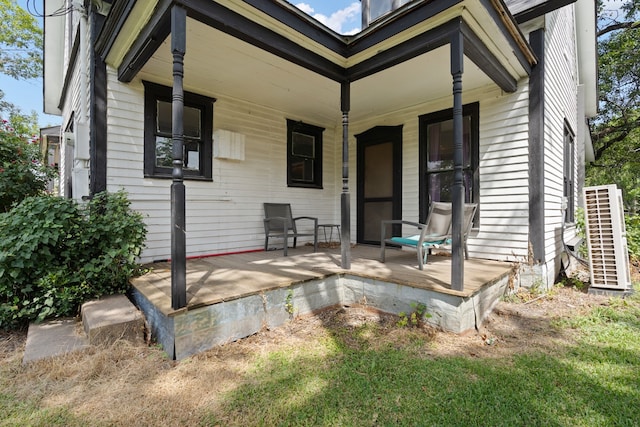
[584,185,631,291]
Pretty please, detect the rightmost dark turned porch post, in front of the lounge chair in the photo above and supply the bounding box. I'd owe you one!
[451,32,464,291]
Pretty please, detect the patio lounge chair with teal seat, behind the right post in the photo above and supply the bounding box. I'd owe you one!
[380,202,477,270]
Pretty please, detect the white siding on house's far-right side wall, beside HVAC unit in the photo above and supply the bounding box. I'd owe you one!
[544,4,578,273]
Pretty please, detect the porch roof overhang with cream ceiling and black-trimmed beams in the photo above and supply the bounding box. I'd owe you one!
[97,0,536,122]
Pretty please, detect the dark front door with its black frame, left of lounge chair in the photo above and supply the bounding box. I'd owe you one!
[356,126,402,245]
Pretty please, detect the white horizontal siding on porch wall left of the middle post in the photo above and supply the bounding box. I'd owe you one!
[107,69,341,261]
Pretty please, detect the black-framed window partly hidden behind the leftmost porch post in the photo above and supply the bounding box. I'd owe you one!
[144,82,215,180]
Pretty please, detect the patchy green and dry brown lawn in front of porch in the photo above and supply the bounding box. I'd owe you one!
[0,280,640,426]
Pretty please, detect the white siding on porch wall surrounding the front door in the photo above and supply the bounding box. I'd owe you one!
[349,85,529,260]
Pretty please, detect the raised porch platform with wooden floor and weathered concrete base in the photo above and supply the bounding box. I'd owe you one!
[132,245,512,359]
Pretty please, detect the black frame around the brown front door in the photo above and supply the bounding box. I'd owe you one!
[355,125,403,244]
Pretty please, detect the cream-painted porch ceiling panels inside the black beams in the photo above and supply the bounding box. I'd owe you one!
[139,19,494,124]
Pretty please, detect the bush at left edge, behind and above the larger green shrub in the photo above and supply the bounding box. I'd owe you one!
[0,121,56,212]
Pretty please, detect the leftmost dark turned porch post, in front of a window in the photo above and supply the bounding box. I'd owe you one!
[171,6,187,310]
